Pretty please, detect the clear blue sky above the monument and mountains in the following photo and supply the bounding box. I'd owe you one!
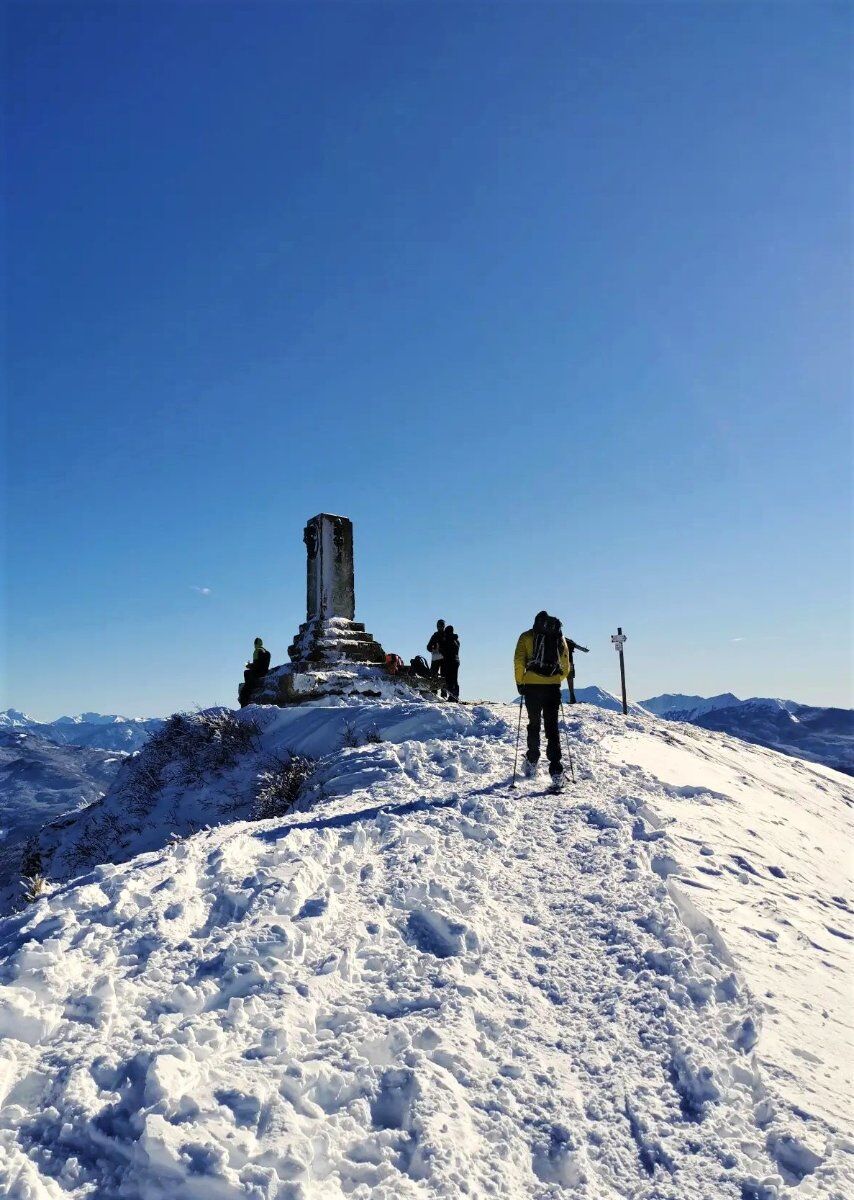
[5,2,852,718]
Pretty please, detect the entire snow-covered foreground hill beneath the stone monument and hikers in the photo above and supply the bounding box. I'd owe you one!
[0,700,854,1200]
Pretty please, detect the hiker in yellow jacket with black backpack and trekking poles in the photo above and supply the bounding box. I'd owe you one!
[513,612,570,788]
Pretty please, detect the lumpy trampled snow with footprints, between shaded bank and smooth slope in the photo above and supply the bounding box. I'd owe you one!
[0,704,854,1200]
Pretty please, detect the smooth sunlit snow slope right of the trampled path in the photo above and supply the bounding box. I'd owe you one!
[604,727,854,1142]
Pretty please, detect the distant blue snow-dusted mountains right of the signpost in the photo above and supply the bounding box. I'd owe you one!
[642,692,854,775]
